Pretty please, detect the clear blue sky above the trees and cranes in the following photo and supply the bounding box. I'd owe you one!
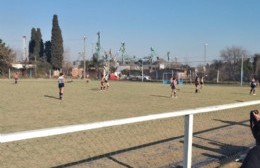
[0,0,260,65]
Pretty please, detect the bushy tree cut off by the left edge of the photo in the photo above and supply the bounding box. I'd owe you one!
[0,39,15,74]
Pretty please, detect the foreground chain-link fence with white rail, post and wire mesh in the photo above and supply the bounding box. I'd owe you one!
[0,101,260,168]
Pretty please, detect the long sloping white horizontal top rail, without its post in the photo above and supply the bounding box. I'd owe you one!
[0,100,260,143]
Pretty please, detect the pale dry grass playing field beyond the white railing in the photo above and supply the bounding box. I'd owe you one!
[0,80,258,133]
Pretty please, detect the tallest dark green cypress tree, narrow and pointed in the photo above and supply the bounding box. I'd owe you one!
[51,15,64,70]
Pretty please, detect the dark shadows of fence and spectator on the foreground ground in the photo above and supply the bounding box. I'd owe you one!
[53,119,254,168]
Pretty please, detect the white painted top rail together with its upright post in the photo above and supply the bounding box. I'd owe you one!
[0,100,260,168]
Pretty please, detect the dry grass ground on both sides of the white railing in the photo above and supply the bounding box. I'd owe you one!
[0,80,259,168]
